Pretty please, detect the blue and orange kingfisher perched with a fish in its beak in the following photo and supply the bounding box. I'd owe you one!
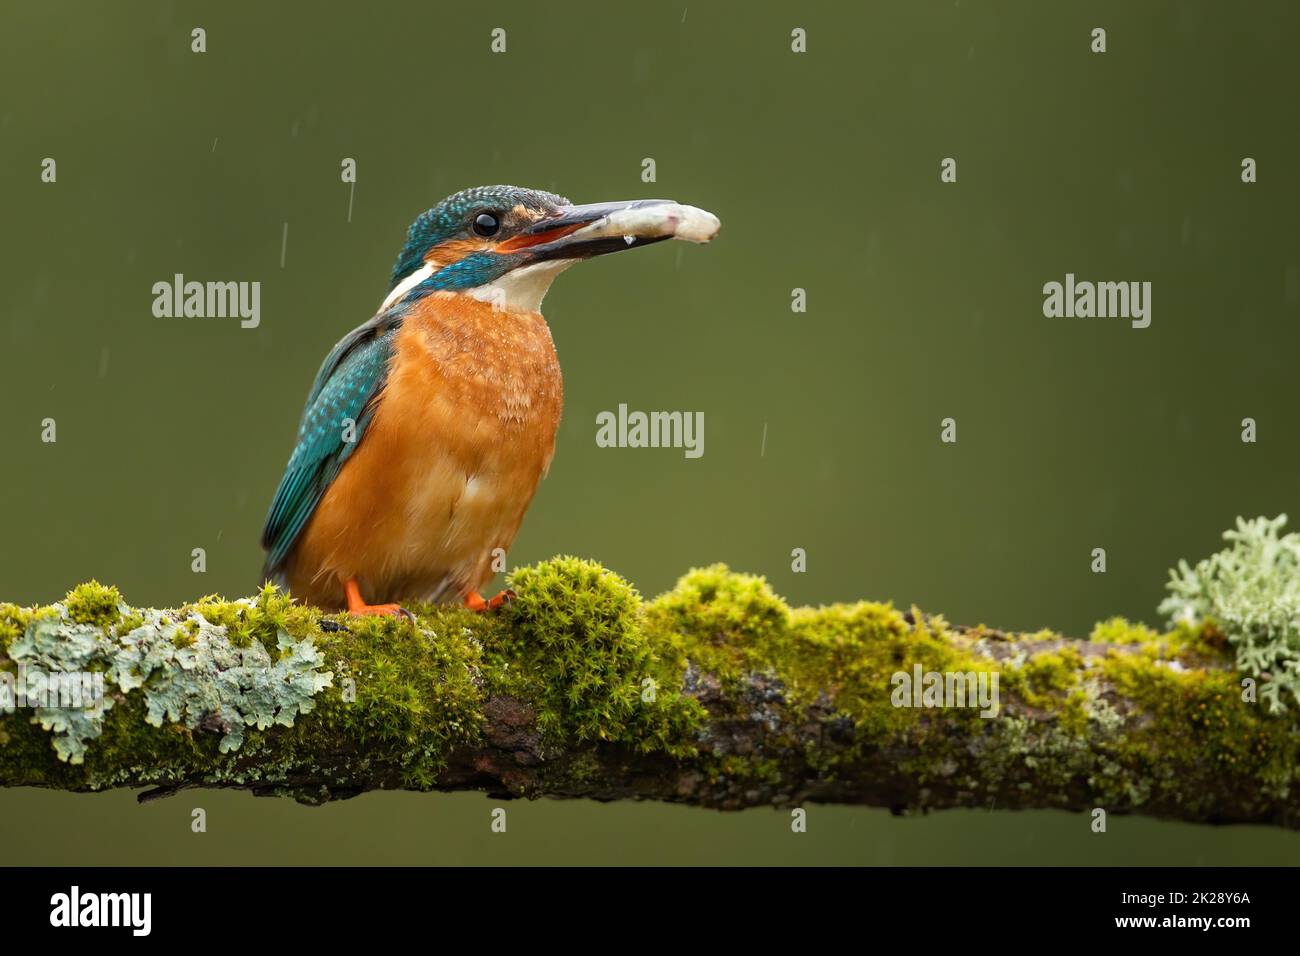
[261,186,720,614]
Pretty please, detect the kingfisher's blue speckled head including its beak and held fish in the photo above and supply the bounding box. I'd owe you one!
[384,186,720,312]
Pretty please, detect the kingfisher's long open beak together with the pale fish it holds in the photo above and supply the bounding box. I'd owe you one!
[498,199,722,261]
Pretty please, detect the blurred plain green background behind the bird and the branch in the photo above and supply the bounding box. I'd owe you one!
[0,0,1300,864]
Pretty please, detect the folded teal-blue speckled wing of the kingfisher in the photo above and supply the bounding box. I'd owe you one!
[254,323,395,576]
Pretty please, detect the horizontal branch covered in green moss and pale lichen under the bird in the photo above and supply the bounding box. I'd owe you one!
[0,558,1300,827]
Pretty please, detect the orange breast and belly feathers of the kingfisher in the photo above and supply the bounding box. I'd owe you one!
[286,294,563,607]
